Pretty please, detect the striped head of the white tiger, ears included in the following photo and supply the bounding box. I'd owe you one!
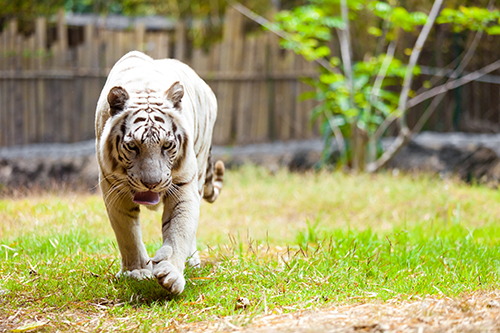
[101,82,187,205]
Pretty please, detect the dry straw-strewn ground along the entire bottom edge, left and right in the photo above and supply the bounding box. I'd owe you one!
[0,291,500,333]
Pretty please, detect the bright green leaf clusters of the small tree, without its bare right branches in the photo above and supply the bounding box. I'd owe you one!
[273,0,500,170]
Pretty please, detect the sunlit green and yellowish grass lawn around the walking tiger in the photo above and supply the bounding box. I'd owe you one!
[0,167,500,331]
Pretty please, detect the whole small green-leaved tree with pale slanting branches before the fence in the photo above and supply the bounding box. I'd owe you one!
[274,0,500,172]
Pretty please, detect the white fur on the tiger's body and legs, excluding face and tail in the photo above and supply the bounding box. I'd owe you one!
[96,51,217,294]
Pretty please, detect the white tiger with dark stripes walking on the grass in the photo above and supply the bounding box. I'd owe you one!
[95,51,224,294]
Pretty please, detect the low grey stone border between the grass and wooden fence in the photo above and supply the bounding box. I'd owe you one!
[0,132,500,191]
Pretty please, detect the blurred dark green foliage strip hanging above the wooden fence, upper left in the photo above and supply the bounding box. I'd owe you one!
[0,0,306,49]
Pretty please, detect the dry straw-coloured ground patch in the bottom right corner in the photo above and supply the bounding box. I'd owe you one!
[176,291,500,333]
